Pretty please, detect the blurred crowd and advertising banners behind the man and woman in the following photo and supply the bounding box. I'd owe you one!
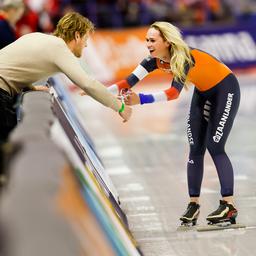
[0,0,256,81]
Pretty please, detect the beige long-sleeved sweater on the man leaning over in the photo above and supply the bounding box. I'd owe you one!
[0,33,118,111]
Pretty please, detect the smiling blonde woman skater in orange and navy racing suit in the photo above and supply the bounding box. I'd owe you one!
[109,22,240,225]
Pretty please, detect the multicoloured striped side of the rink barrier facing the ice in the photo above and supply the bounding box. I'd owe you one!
[50,76,142,256]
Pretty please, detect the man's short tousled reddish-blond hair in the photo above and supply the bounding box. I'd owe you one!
[53,12,94,43]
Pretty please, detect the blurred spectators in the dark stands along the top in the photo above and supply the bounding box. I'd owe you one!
[11,0,256,35]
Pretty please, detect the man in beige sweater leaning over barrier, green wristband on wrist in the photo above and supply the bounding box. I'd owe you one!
[0,12,132,143]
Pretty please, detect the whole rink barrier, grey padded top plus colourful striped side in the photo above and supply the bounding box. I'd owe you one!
[0,91,141,256]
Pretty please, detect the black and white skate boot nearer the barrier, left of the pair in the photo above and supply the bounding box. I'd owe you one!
[180,202,200,226]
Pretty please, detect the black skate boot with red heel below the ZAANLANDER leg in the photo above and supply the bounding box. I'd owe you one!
[206,200,237,224]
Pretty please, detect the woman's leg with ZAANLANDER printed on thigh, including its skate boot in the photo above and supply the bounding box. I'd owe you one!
[207,75,240,223]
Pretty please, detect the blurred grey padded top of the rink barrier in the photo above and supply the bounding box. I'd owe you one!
[0,92,80,256]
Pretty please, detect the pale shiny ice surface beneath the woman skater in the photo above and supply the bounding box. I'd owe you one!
[73,74,256,256]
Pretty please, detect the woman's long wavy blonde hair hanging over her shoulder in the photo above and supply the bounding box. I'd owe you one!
[150,21,193,88]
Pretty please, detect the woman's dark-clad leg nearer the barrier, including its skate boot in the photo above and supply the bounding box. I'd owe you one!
[180,89,209,225]
